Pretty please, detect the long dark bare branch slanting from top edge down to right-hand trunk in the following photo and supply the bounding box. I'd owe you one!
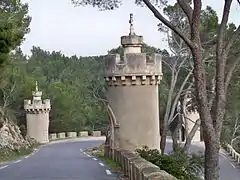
[143,0,193,47]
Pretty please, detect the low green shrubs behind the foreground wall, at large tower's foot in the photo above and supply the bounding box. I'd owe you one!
[137,147,203,180]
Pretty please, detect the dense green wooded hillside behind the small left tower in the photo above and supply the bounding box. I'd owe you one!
[0,40,171,135]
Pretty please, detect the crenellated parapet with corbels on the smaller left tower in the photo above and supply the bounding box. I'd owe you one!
[24,99,51,112]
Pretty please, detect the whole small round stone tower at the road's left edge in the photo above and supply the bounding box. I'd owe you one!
[24,82,51,143]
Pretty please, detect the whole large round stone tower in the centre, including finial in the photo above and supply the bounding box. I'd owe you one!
[105,14,162,150]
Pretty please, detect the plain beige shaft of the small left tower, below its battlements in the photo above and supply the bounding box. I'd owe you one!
[26,112,49,144]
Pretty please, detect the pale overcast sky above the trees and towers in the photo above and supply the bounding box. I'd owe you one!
[21,0,240,56]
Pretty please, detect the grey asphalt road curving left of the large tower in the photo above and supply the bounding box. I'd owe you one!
[0,140,116,180]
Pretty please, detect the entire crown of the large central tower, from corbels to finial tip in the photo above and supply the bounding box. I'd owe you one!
[105,14,162,86]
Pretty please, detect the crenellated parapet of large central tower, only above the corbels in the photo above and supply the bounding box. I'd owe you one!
[105,53,162,77]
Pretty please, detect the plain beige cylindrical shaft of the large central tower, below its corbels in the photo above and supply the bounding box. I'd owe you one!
[108,85,160,150]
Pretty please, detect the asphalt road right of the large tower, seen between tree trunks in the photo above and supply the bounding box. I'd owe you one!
[166,141,240,180]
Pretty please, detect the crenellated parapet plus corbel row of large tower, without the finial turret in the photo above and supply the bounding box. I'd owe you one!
[105,53,162,86]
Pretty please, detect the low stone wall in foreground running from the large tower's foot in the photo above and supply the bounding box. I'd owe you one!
[110,149,177,180]
